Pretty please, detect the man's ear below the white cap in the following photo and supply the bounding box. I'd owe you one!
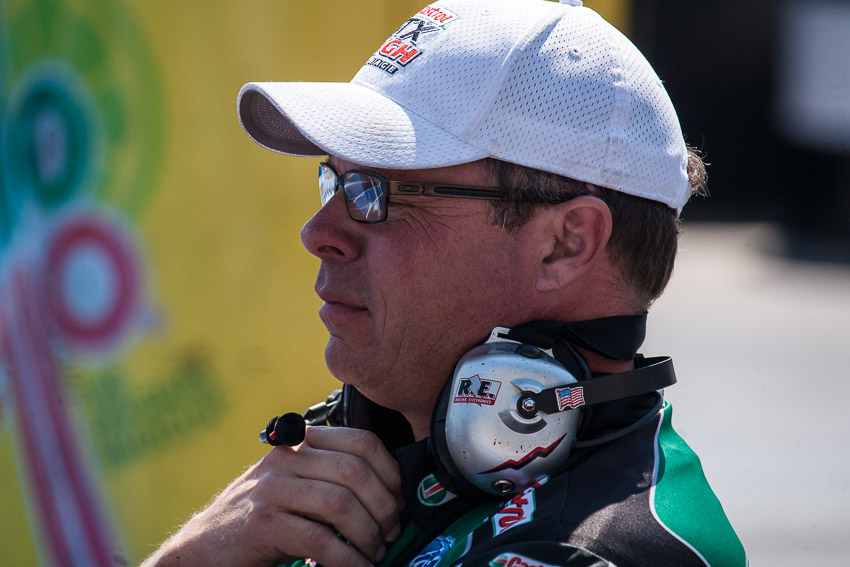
[537,195,613,292]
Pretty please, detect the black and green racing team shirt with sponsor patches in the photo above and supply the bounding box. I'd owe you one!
[290,403,748,567]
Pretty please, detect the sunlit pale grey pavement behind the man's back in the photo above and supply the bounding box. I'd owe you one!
[643,224,850,567]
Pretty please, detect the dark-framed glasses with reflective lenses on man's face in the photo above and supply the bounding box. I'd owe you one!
[319,162,501,223]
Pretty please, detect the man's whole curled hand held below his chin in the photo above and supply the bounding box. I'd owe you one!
[144,427,403,567]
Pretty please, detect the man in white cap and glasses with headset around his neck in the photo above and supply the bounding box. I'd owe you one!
[147,0,746,567]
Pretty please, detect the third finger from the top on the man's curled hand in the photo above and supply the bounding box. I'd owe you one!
[252,477,384,561]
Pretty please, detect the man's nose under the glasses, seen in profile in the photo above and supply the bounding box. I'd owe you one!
[301,191,362,261]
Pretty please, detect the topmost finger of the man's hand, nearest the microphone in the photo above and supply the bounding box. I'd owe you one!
[305,427,402,496]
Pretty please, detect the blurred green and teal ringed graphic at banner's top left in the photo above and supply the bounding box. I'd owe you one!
[2,1,165,220]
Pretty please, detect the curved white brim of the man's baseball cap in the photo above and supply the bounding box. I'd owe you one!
[237,83,488,169]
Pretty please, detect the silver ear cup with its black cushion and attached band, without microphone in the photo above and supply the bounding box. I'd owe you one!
[429,323,676,496]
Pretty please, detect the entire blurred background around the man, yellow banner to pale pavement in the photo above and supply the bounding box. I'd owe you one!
[0,0,850,566]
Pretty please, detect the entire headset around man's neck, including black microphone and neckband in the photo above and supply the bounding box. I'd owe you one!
[260,314,676,497]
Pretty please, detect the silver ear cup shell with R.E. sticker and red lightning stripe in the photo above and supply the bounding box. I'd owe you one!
[445,339,579,495]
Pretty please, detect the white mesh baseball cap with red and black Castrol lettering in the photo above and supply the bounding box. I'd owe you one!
[237,0,691,211]
